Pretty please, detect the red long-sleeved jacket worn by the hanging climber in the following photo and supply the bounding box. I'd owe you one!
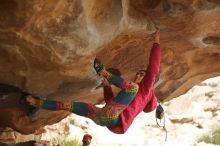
[104,43,161,134]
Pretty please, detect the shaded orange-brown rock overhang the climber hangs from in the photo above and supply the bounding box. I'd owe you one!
[0,0,220,134]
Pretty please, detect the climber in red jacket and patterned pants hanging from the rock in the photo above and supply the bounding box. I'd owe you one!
[27,29,161,134]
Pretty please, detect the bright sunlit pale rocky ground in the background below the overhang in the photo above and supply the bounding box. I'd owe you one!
[0,77,220,146]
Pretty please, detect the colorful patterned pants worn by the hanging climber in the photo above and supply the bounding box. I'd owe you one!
[40,70,138,127]
